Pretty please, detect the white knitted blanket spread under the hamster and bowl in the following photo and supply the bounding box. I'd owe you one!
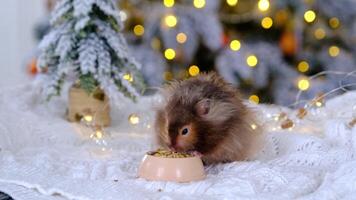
[0,85,356,200]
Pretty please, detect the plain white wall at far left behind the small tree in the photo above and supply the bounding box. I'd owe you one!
[0,0,45,87]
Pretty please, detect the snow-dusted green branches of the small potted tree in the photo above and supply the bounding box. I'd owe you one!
[38,0,144,100]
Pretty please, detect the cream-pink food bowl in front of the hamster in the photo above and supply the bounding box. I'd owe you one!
[138,154,205,182]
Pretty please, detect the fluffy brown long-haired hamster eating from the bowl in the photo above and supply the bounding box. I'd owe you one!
[155,73,262,164]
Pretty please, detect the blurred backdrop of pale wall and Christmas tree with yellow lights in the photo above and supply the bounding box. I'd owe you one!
[0,0,356,105]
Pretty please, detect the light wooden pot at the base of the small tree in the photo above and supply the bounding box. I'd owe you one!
[67,86,111,126]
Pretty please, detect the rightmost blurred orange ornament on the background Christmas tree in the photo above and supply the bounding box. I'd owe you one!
[279,31,297,56]
